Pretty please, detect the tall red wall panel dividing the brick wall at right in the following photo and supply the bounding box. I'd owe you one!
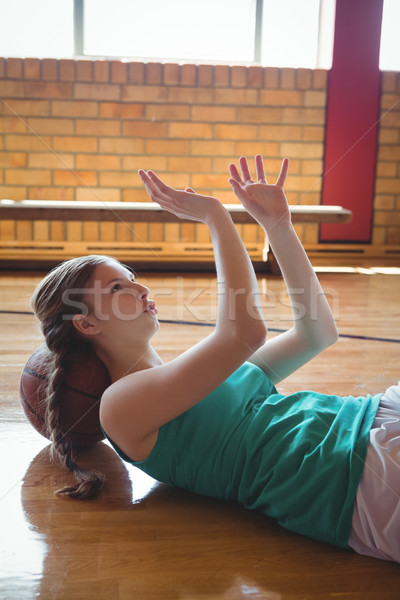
[320,0,383,242]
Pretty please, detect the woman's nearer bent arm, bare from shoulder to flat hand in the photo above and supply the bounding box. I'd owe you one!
[100,171,266,460]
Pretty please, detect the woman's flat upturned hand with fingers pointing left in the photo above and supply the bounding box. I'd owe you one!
[139,169,222,223]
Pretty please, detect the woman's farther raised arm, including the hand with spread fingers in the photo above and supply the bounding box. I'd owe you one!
[230,156,338,383]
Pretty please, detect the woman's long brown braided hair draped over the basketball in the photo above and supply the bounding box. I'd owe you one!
[31,255,118,499]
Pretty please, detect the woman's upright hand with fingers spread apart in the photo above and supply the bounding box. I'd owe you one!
[229,154,290,231]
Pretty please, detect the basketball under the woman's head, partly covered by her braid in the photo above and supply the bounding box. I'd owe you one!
[20,345,110,447]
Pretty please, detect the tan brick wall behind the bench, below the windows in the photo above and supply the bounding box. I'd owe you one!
[0,58,400,264]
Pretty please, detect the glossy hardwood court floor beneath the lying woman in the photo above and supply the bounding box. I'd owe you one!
[0,270,400,600]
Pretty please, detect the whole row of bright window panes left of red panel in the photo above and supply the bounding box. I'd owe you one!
[0,0,344,68]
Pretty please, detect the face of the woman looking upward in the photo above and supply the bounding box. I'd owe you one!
[79,260,159,340]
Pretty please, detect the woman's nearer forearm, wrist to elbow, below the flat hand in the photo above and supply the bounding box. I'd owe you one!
[207,205,266,341]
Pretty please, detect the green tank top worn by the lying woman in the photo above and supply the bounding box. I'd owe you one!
[101,363,381,548]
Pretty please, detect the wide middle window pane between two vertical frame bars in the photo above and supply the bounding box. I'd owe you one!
[83,0,255,62]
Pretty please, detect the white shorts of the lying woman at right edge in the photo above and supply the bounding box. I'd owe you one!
[349,382,400,562]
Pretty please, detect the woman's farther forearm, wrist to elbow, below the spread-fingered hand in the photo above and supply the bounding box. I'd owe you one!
[267,223,338,345]
